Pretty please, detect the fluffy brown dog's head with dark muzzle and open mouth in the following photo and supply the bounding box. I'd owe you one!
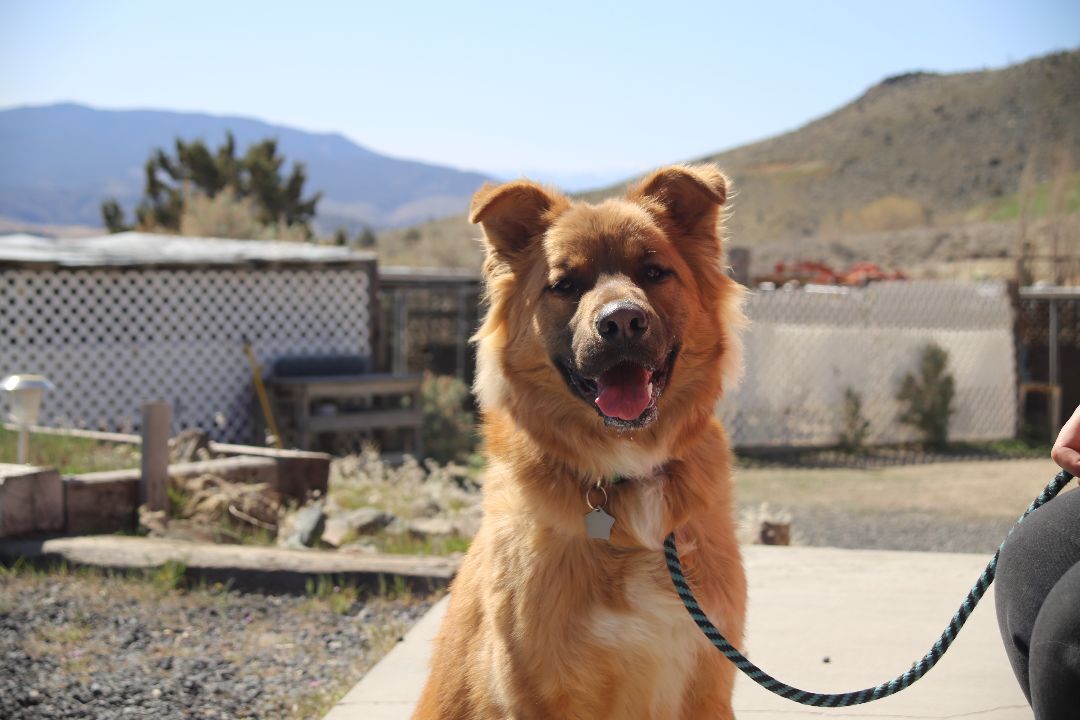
[470,165,741,459]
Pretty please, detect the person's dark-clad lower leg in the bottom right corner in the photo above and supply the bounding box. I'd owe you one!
[1028,562,1080,720]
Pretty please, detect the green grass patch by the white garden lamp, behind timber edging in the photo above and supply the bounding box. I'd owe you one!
[0,427,139,475]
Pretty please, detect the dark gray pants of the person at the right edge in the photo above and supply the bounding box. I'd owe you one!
[995,483,1080,720]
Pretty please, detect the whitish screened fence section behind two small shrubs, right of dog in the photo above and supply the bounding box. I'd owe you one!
[719,282,1016,447]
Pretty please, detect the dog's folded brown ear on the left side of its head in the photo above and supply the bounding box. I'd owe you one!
[469,180,569,258]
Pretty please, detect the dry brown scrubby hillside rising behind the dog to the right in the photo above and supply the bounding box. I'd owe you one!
[380,51,1080,274]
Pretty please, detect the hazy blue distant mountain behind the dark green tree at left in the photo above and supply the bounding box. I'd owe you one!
[0,104,487,231]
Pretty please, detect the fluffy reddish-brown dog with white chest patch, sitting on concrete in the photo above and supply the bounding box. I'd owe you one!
[414,165,746,720]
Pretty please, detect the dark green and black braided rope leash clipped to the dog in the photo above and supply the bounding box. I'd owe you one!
[664,470,1072,707]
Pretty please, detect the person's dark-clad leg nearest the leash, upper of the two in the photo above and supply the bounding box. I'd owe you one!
[994,490,1080,702]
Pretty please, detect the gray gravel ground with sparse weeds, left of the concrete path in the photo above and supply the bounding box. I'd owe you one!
[0,569,434,720]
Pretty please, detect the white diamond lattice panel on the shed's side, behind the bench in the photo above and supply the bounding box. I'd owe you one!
[0,264,374,441]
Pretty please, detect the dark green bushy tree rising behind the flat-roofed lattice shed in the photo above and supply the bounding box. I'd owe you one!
[102,133,322,239]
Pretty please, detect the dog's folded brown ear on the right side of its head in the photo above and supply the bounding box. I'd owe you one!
[626,165,728,234]
